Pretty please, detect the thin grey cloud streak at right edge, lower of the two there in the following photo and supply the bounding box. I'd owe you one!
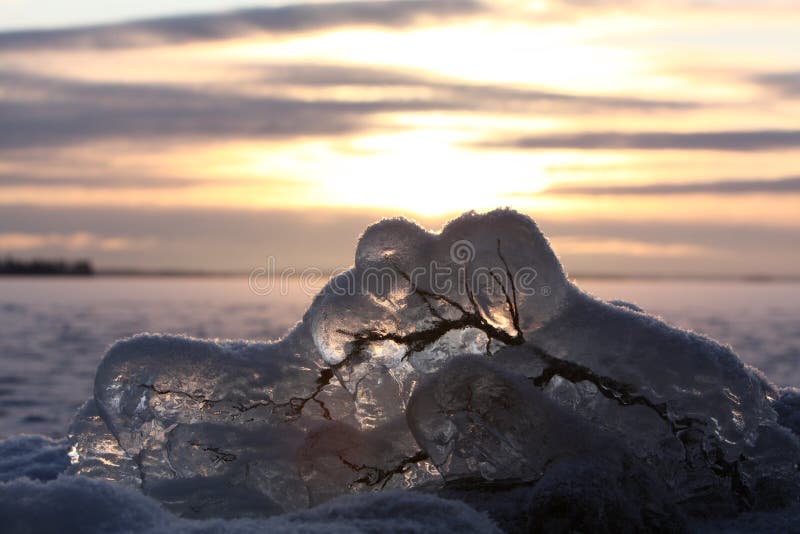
[537,176,800,195]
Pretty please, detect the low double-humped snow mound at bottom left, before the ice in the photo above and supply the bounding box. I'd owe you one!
[0,476,499,534]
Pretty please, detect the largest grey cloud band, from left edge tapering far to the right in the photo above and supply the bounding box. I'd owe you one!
[0,65,691,150]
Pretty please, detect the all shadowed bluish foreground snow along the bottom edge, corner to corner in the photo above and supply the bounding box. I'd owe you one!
[0,436,800,534]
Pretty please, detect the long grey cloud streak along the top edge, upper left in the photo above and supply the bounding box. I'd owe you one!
[0,0,485,52]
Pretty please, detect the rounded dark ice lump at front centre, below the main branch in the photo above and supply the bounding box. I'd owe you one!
[408,356,600,481]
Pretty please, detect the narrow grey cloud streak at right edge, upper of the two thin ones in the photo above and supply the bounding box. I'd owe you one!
[473,130,800,152]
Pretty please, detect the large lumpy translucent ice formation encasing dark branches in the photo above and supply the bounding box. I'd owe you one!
[70,210,800,530]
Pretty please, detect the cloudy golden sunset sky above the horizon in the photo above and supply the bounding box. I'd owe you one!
[0,0,800,276]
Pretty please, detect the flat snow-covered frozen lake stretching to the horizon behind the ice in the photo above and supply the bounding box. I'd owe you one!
[0,277,800,439]
